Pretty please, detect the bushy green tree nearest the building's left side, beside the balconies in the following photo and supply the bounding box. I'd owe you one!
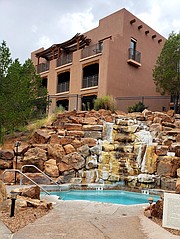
[4,60,47,131]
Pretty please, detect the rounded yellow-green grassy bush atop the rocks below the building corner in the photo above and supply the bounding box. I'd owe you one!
[94,95,116,112]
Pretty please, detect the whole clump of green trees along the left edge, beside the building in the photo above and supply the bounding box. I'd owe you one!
[0,42,47,142]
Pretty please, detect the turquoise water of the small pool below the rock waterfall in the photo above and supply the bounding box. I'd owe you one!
[45,190,160,205]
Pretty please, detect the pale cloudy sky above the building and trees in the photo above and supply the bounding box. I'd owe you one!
[0,0,180,64]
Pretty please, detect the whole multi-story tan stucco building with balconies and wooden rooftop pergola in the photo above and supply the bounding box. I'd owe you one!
[32,9,169,112]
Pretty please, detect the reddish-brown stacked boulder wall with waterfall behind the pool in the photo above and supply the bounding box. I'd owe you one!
[0,110,180,192]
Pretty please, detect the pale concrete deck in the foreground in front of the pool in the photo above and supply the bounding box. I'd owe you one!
[0,200,179,239]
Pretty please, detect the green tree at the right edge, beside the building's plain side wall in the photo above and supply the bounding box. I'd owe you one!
[153,32,180,112]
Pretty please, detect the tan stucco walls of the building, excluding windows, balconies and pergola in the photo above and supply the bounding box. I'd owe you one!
[32,9,168,112]
